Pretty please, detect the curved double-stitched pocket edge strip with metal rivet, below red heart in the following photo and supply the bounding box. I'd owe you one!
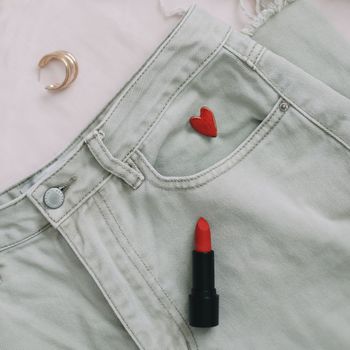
[131,98,290,190]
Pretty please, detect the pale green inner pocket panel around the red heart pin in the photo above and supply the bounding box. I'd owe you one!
[131,43,280,183]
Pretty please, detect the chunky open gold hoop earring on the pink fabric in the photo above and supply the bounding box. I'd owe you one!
[38,50,79,91]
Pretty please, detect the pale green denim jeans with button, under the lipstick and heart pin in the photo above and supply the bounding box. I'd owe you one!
[0,3,350,350]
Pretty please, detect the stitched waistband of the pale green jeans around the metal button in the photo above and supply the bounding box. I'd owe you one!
[0,5,261,241]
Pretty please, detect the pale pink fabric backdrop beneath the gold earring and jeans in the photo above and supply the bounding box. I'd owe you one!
[0,0,350,190]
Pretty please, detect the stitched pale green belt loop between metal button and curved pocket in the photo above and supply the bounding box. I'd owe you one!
[84,130,144,190]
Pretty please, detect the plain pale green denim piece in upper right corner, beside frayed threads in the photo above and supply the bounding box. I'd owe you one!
[253,0,350,98]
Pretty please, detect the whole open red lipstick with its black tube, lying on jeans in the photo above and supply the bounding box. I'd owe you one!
[189,217,219,327]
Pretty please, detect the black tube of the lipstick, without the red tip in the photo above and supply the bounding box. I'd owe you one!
[189,250,219,327]
